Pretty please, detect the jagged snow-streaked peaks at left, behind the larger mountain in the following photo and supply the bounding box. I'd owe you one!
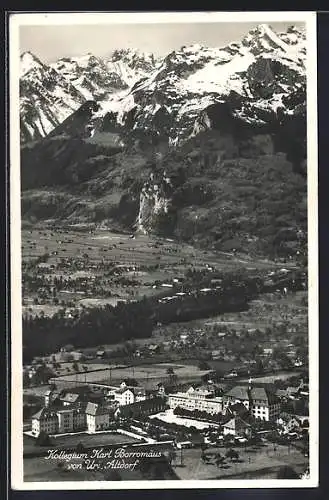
[20,49,157,142]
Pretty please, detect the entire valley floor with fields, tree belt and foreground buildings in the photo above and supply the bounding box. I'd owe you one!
[23,231,309,480]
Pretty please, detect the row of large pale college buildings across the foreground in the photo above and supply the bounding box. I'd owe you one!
[32,380,308,437]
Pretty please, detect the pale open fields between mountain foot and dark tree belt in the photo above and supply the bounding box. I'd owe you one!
[22,228,293,316]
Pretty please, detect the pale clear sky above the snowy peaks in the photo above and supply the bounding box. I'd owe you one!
[19,21,301,63]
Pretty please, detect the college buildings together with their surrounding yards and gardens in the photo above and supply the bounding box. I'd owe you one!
[24,340,309,477]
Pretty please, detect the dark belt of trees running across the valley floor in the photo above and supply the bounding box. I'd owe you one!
[23,272,256,361]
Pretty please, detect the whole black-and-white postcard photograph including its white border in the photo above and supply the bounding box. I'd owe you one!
[9,12,318,490]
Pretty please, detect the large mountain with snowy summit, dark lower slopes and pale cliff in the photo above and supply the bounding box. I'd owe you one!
[21,25,307,256]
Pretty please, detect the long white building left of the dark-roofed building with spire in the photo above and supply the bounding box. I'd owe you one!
[168,387,223,415]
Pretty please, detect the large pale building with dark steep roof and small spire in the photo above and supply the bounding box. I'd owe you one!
[223,384,280,421]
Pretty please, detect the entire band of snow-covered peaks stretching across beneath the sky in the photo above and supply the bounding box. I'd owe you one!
[21,24,306,145]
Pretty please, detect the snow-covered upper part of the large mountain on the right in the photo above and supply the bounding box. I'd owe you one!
[89,25,306,144]
